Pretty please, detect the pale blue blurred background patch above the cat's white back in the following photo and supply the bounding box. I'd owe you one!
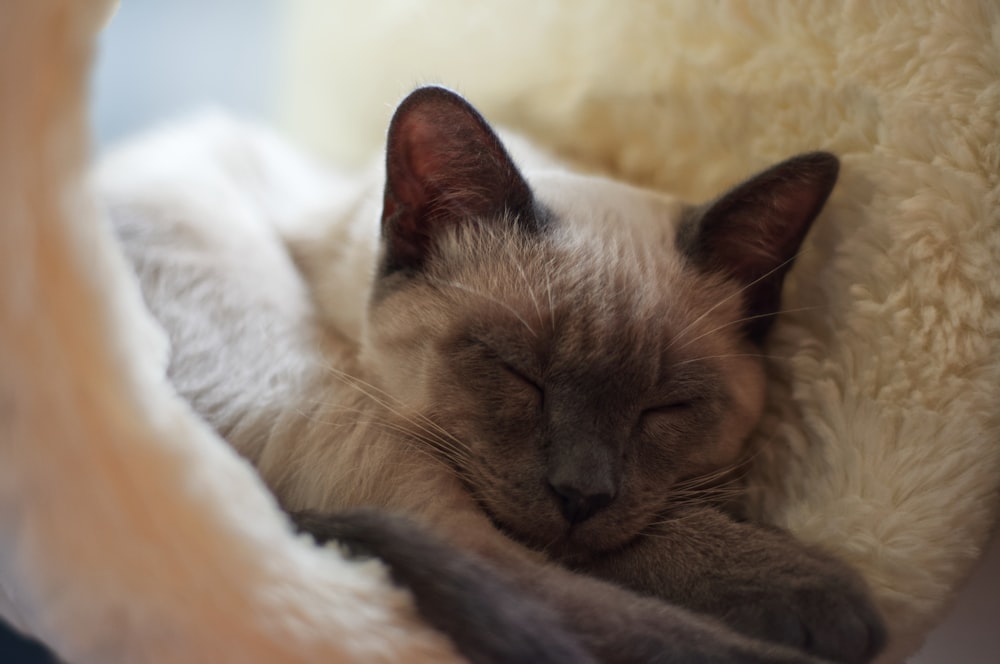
[92,0,284,148]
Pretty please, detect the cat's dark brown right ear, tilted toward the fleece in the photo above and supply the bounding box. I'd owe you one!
[677,152,840,342]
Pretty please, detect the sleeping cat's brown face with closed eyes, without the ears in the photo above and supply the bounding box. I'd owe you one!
[371,185,763,550]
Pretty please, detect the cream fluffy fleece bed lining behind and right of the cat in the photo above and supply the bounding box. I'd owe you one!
[287,0,1000,661]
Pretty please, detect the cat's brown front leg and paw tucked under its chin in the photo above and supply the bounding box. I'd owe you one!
[567,507,886,664]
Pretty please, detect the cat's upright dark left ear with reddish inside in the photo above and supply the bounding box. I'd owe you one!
[382,87,535,274]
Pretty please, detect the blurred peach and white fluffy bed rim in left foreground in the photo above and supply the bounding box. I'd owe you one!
[0,0,459,664]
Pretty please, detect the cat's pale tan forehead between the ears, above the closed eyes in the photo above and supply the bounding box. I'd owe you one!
[439,174,740,367]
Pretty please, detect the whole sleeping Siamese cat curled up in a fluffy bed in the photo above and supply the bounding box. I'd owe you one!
[107,87,885,663]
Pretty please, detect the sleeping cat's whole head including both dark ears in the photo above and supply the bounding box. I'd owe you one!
[363,88,838,553]
